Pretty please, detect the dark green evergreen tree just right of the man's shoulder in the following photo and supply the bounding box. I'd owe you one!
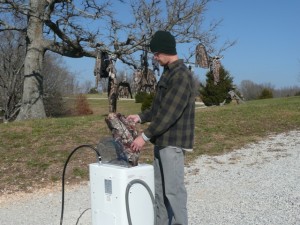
[200,66,235,106]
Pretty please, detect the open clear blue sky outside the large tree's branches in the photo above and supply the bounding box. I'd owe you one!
[65,0,300,88]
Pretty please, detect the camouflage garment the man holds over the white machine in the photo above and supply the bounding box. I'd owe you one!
[105,113,140,166]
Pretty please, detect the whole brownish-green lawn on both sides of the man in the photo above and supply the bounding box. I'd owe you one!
[0,95,300,195]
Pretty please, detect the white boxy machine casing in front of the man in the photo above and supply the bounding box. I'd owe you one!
[89,163,154,225]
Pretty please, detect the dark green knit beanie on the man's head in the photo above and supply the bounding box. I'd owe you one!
[150,30,177,55]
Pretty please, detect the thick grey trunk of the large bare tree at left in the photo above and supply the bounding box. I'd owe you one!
[17,0,46,120]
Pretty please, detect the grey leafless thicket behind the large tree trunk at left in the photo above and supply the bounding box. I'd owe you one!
[0,36,78,122]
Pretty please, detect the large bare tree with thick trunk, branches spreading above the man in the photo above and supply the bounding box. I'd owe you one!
[0,0,230,120]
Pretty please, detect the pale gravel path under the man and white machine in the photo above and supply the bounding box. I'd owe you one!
[0,131,300,225]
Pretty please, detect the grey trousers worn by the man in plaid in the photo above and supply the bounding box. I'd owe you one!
[153,146,188,225]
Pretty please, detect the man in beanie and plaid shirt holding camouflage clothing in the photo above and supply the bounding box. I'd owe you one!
[127,31,195,225]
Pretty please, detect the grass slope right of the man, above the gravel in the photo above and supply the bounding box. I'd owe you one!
[188,97,300,162]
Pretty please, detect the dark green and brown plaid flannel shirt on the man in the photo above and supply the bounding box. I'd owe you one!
[139,60,195,149]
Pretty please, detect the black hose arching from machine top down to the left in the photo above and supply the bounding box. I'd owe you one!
[60,144,101,225]
